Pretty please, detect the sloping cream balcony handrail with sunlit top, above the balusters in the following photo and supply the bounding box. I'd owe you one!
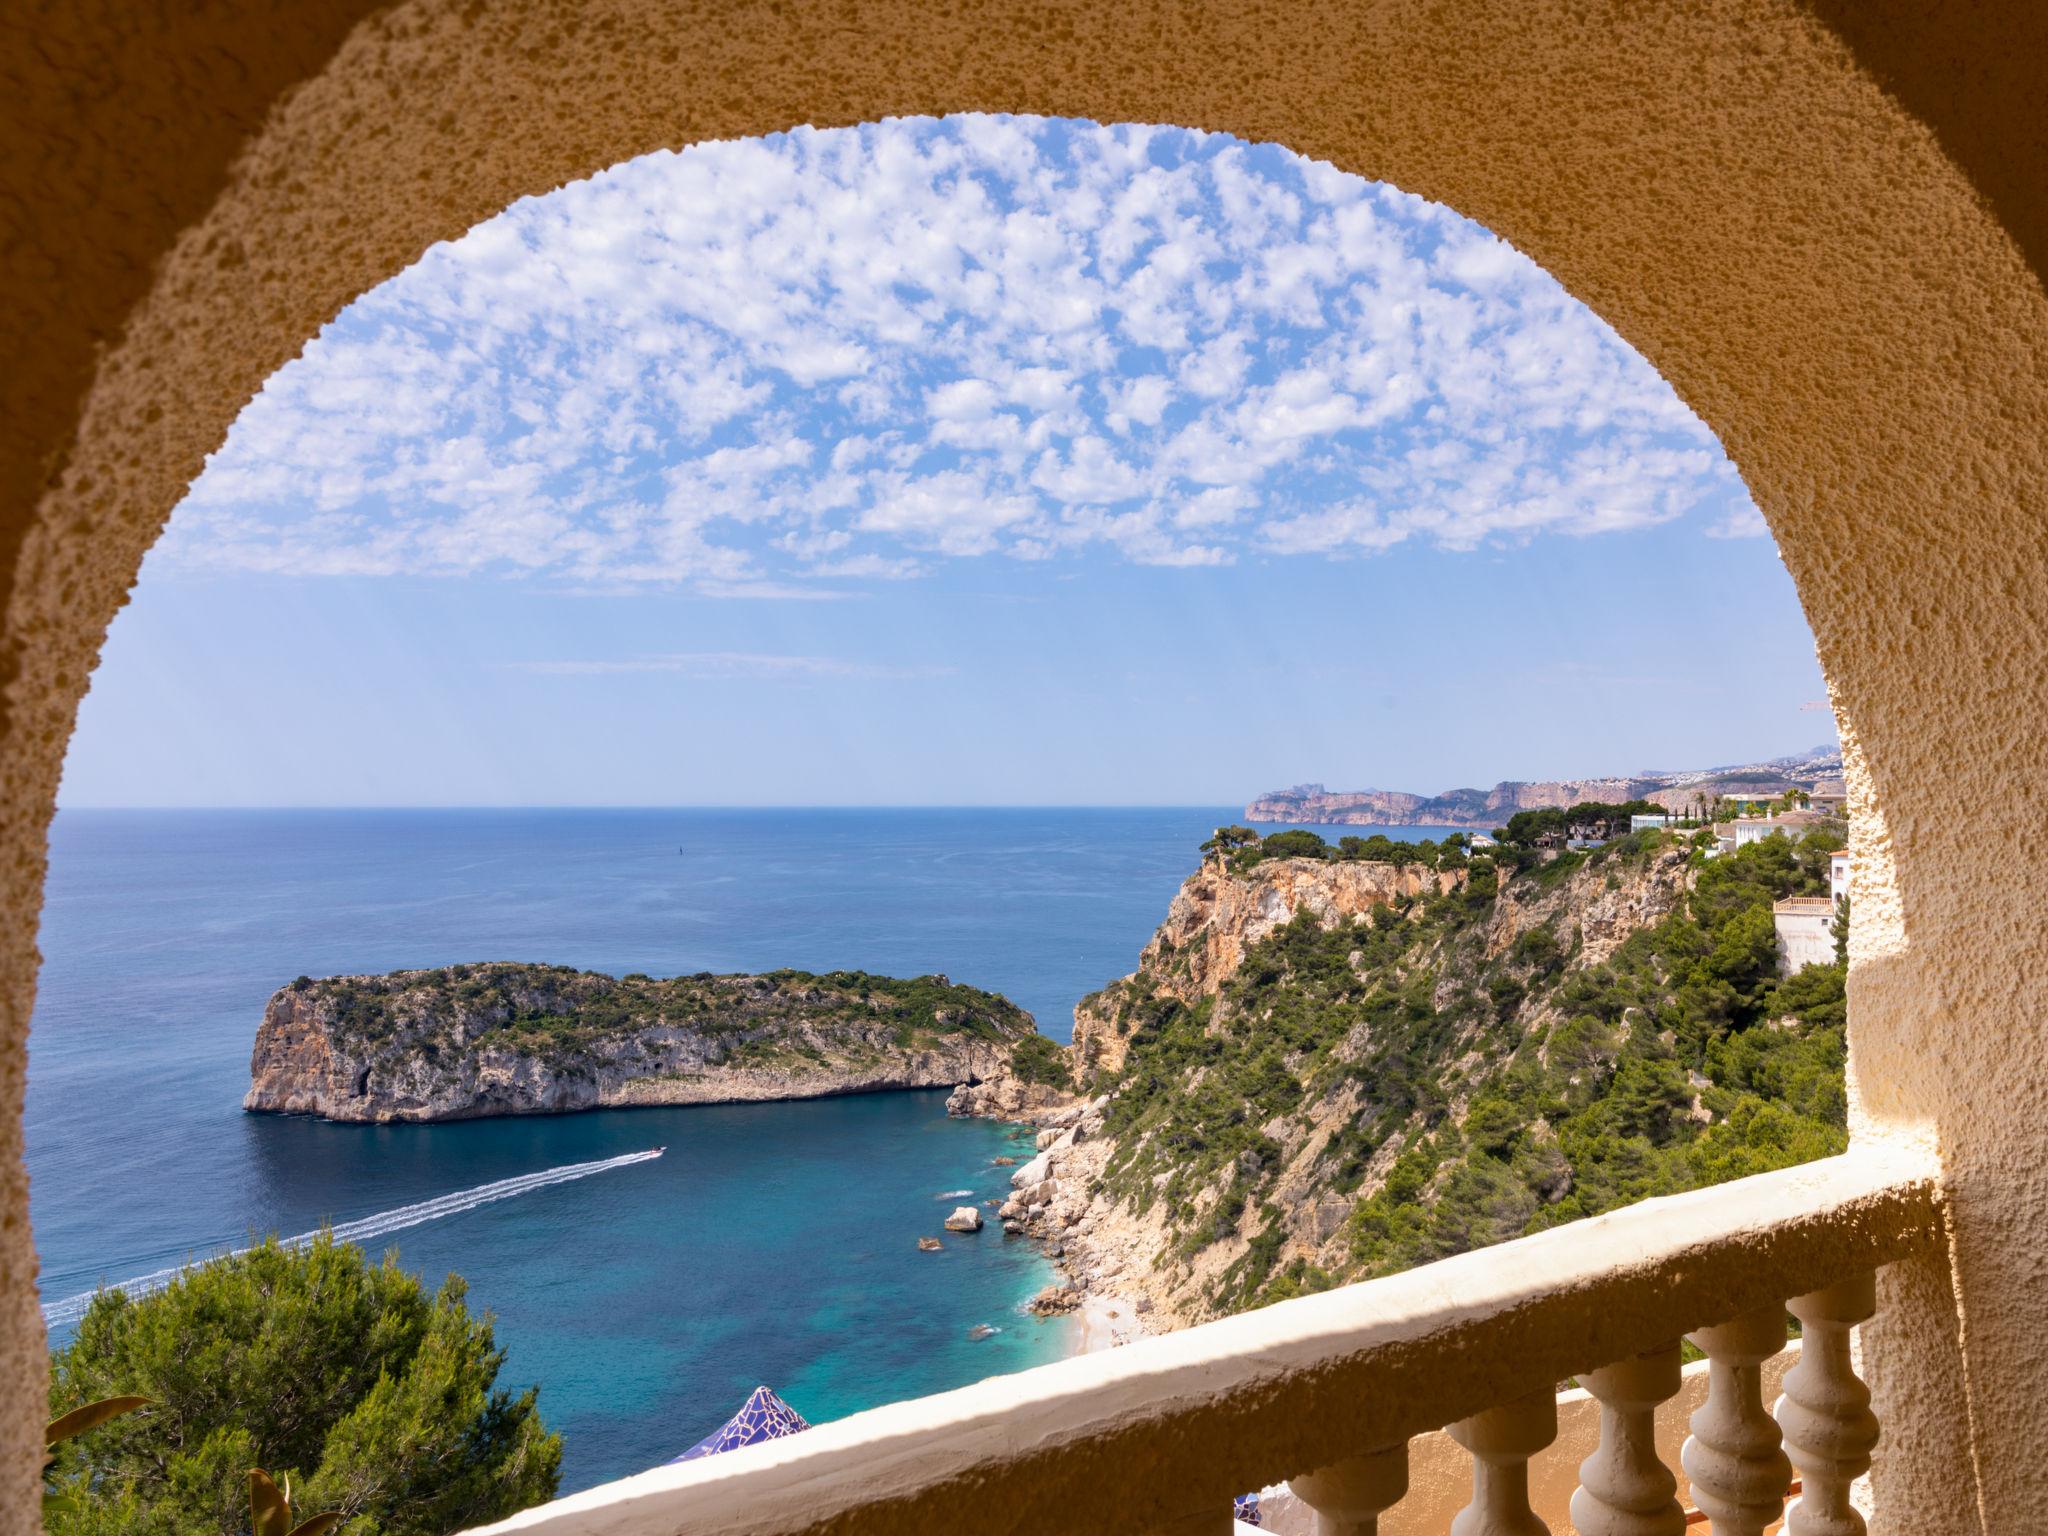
[471,1147,1944,1536]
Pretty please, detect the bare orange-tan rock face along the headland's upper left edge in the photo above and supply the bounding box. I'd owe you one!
[1073,854,1464,1083]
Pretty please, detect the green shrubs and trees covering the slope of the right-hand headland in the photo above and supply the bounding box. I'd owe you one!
[1104,823,1847,1311]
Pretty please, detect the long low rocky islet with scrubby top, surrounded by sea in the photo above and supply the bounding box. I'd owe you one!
[242,963,1034,1122]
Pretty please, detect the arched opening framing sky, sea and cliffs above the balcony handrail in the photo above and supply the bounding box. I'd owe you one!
[29,117,1843,1515]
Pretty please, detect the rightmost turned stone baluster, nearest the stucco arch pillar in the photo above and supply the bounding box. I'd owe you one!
[1772,1274,1878,1536]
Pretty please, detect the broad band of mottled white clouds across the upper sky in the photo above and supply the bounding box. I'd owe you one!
[158,117,1765,598]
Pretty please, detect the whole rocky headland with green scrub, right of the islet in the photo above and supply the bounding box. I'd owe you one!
[948,831,1845,1331]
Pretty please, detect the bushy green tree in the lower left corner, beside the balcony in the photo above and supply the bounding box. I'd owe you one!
[49,1237,561,1536]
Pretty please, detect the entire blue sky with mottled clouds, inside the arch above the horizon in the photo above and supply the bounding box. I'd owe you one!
[61,119,1831,805]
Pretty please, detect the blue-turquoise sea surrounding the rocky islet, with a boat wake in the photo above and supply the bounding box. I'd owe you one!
[27,807,1442,1493]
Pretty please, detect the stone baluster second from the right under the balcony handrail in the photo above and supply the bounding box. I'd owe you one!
[1679,1307,1792,1536]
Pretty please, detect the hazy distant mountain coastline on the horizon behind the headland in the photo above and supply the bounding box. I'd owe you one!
[1245,745,1841,827]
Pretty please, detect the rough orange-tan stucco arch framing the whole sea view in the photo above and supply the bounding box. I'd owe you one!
[0,0,2048,1530]
